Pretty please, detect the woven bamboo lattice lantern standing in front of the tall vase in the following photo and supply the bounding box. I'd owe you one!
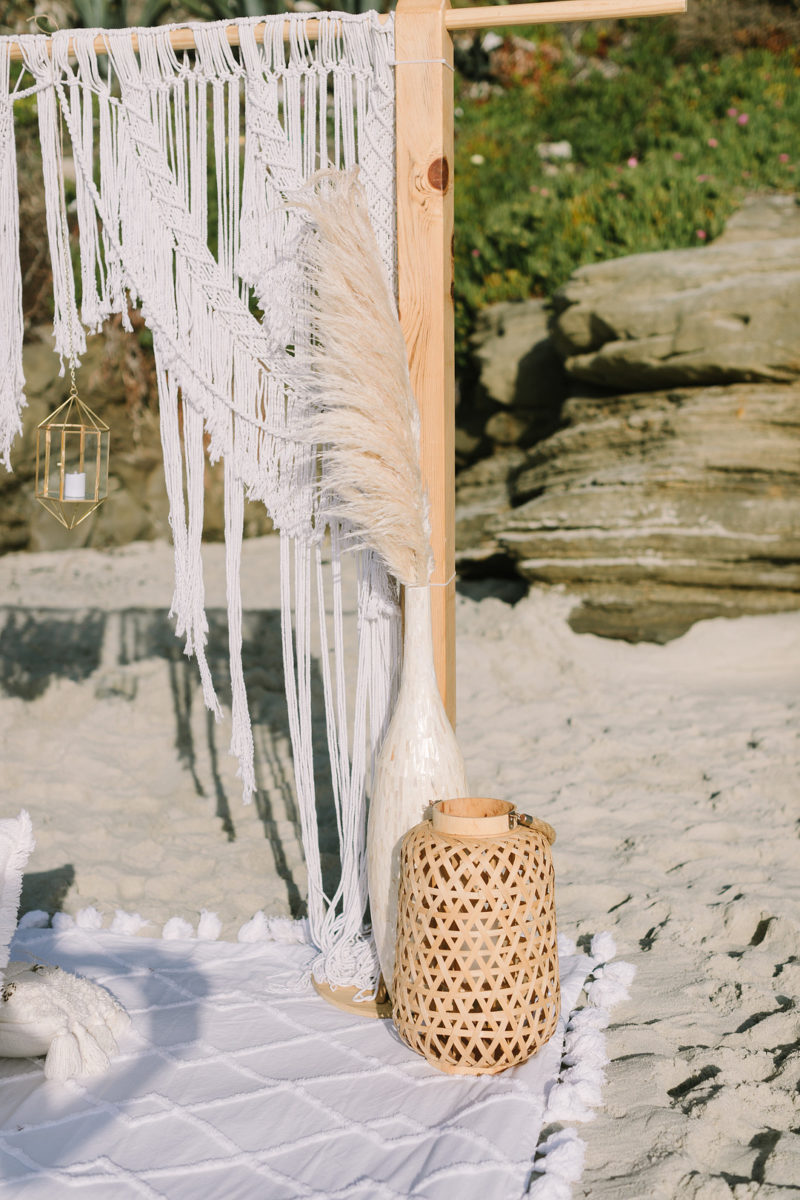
[392,797,560,1075]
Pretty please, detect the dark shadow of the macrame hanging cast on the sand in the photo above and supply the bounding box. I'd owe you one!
[0,606,338,916]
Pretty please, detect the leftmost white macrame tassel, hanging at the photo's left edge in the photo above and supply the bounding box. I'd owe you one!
[0,42,25,470]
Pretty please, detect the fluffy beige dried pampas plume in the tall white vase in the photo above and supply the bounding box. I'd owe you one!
[289,169,433,587]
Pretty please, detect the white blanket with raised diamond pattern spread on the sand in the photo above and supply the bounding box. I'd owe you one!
[0,926,602,1200]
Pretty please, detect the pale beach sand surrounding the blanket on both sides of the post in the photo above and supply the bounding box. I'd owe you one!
[0,539,800,1200]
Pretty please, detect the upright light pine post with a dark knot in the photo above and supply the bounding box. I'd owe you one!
[395,0,456,725]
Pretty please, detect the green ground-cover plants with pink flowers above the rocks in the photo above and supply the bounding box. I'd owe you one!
[456,14,800,370]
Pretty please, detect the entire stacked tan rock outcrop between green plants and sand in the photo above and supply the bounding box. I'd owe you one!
[457,197,800,641]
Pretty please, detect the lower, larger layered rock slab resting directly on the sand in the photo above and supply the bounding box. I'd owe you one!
[494,384,800,641]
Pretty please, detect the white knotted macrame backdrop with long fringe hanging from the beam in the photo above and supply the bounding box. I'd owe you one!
[0,12,398,990]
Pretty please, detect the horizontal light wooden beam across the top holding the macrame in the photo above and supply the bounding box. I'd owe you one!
[10,0,686,62]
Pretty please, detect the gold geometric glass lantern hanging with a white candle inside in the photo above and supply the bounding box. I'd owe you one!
[36,389,109,529]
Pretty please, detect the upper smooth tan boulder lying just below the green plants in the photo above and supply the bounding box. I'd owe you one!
[553,238,800,391]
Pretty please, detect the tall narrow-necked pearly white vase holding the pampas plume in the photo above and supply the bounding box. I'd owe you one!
[367,584,468,988]
